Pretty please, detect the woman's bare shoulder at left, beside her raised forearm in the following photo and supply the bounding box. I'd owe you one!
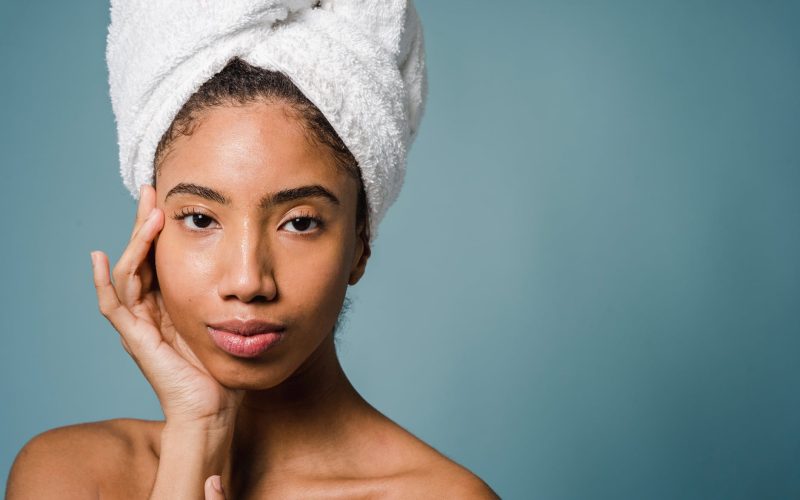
[6,418,160,500]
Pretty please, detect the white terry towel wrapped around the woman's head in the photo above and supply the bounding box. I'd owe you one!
[106,0,427,241]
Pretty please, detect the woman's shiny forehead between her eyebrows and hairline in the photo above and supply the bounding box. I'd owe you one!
[157,102,356,203]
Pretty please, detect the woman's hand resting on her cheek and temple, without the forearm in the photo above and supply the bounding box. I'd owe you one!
[92,185,244,430]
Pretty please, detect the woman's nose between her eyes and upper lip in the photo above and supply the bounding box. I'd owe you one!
[218,228,278,302]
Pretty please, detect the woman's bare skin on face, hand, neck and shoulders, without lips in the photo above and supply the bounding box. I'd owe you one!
[8,102,498,499]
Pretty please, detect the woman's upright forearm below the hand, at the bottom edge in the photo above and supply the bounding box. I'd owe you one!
[150,423,233,500]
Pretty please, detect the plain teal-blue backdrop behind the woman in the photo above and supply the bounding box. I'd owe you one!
[0,0,800,499]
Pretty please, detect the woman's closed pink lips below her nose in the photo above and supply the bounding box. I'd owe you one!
[208,319,286,358]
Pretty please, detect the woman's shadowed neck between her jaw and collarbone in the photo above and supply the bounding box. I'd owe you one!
[223,335,372,491]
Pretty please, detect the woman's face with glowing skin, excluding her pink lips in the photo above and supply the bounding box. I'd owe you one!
[155,102,368,389]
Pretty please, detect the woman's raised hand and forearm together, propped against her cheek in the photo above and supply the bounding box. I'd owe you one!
[92,186,244,500]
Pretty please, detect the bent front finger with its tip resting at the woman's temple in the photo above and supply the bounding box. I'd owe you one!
[113,208,164,307]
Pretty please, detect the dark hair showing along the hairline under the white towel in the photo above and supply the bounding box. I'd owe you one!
[153,57,370,247]
